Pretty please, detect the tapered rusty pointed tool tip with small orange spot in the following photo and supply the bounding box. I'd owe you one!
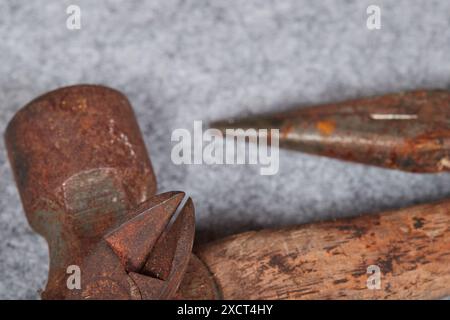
[211,90,450,172]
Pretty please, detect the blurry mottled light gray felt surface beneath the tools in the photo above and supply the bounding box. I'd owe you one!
[0,0,450,299]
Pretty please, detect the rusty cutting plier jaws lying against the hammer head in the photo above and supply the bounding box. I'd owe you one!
[67,192,195,299]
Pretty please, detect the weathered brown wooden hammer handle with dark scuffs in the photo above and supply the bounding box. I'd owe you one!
[196,201,450,299]
